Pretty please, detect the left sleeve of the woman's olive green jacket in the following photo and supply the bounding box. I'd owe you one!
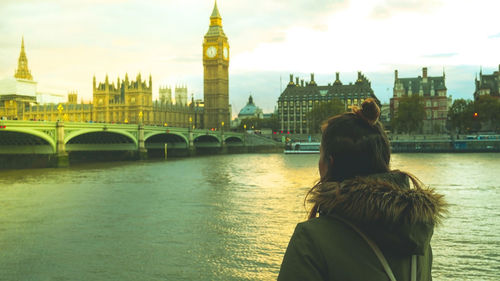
[278,224,326,281]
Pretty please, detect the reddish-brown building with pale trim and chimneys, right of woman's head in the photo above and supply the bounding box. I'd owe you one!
[390,67,451,134]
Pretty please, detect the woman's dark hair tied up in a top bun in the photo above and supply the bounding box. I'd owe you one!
[320,98,391,182]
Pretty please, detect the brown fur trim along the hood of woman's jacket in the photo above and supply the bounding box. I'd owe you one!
[308,168,447,225]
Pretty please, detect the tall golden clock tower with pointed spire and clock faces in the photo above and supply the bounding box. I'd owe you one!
[203,2,230,130]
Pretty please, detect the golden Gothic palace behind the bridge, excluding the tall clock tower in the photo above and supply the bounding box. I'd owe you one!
[0,39,203,128]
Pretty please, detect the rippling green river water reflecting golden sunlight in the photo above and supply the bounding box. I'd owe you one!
[0,153,500,281]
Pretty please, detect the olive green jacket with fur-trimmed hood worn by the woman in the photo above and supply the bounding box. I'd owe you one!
[278,171,446,281]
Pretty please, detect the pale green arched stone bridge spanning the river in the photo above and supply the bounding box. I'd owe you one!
[0,120,280,166]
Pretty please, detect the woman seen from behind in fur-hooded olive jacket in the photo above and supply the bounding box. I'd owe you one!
[278,99,446,281]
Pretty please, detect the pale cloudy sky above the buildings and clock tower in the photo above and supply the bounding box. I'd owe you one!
[0,0,500,115]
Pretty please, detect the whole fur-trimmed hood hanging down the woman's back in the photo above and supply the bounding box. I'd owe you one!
[309,171,447,255]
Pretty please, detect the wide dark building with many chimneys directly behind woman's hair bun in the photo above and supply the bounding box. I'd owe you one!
[278,72,380,134]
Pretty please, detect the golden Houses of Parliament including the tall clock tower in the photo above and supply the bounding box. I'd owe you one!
[0,3,230,129]
